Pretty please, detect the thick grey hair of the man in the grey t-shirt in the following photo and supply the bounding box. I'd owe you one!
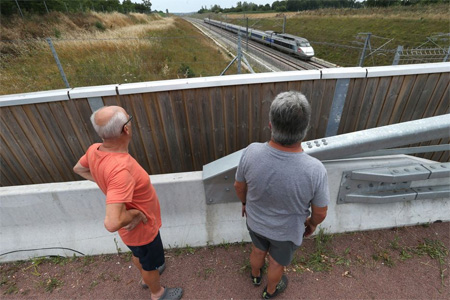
[269,91,311,145]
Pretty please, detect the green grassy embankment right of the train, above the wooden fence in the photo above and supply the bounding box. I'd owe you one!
[221,5,450,67]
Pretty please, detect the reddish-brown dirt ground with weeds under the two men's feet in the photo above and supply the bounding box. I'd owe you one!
[0,222,450,299]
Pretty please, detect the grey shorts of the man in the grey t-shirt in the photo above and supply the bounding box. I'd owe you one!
[247,225,298,266]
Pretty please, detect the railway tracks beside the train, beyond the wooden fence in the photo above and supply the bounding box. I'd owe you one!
[186,18,336,71]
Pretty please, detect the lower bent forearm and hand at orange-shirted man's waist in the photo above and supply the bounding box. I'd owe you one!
[104,203,147,232]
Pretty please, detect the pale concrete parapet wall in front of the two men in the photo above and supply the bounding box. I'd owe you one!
[0,155,450,262]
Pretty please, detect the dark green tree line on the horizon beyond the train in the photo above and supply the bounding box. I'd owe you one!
[198,0,450,14]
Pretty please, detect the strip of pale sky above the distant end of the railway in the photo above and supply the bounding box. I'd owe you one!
[149,0,275,13]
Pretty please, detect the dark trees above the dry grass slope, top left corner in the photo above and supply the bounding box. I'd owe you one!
[0,0,152,16]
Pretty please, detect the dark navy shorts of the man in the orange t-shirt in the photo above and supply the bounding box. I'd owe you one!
[127,232,165,271]
